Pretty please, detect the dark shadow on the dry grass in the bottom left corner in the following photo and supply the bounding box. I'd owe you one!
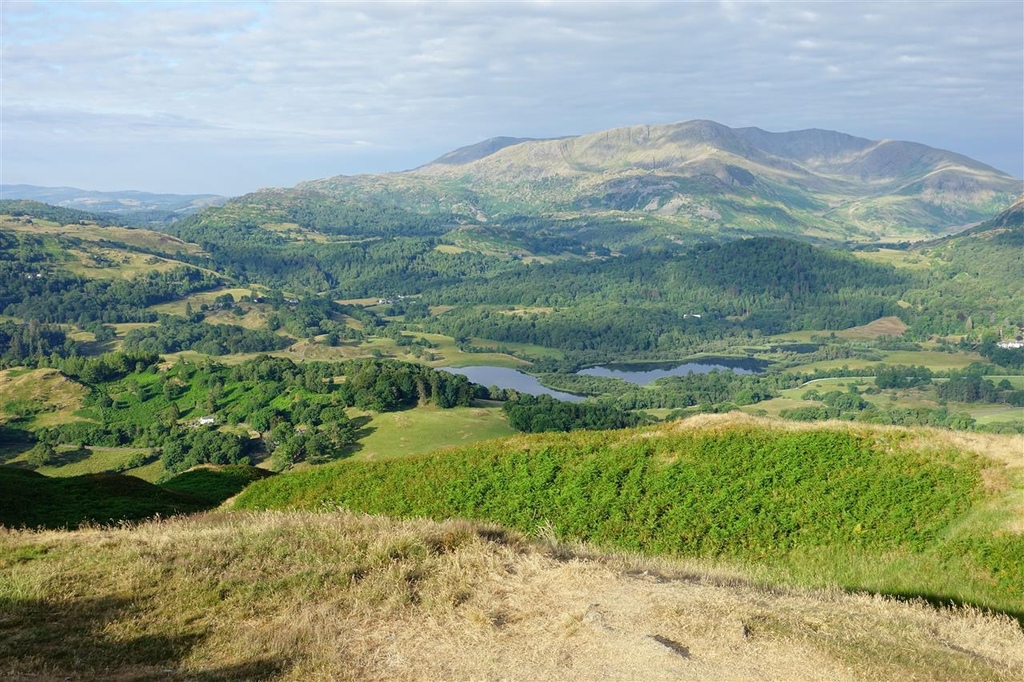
[0,597,287,680]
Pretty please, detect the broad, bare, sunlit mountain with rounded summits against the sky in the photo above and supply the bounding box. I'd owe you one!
[296,121,1024,240]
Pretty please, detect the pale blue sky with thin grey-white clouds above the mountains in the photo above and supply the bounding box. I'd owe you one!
[0,0,1024,196]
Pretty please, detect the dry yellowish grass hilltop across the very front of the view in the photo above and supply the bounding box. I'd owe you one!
[0,513,1024,680]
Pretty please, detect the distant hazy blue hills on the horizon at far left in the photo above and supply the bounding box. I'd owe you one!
[0,184,227,216]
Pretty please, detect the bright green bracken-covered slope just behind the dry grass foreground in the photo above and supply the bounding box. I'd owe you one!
[236,417,1024,619]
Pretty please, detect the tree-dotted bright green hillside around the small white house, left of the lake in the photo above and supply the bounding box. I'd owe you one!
[36,351,476,471]
